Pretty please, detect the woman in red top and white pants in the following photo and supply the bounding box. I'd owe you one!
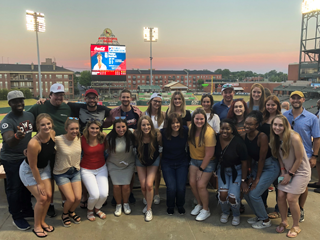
[80,119,109,221]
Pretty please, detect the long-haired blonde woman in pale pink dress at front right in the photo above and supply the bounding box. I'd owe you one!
[270,115,311,238]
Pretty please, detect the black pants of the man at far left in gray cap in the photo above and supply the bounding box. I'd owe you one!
[1,159,33,220]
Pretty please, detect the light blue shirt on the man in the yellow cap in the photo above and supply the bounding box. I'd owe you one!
[283,109,320,158]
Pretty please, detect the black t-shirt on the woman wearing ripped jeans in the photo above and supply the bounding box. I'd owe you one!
[214,134,248,168]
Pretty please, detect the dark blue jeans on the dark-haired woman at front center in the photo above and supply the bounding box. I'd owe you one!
[161,161,189,208]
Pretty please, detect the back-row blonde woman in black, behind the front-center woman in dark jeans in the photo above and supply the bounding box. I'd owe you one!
[166,91,191,127]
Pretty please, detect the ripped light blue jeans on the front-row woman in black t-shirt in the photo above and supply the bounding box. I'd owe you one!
[217,164,242,217]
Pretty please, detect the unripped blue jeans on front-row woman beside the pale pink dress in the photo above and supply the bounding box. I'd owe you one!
[244,157,280,220]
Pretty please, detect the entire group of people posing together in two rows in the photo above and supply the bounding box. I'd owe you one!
[1,83,320,237]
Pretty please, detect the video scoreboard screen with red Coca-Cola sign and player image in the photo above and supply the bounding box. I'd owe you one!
[90,44,126,81]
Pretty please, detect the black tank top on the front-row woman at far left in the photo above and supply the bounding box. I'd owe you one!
[26,138,56,168]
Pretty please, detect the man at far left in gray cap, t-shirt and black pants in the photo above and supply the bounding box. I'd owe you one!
[0,91,35,230]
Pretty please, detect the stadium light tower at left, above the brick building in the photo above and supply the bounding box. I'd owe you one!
[26,10,46,98]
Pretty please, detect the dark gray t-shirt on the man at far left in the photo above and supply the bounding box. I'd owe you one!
[0,112,34,161]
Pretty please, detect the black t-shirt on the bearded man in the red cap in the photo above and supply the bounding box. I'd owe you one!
[68,102,111,133]
